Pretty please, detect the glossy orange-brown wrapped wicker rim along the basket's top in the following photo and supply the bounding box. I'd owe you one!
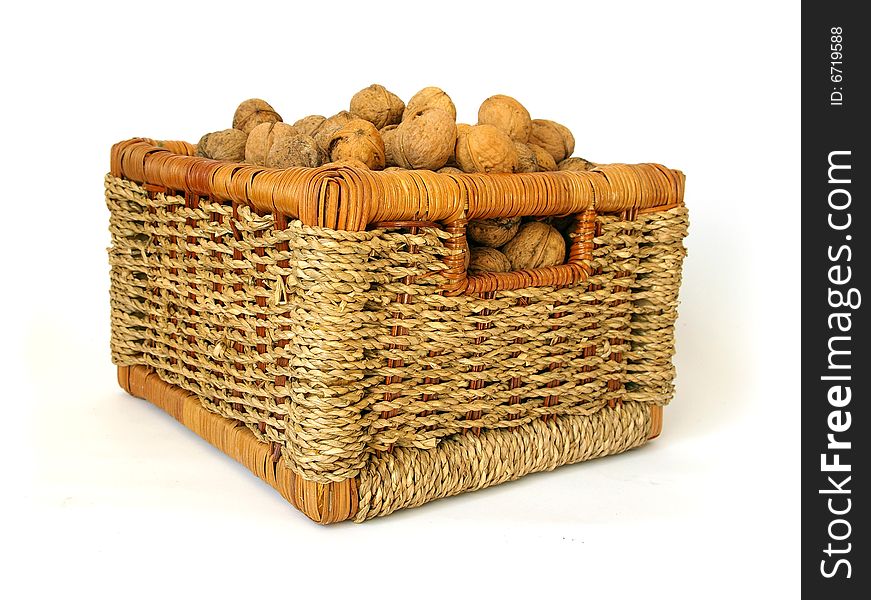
[110,138,685,231]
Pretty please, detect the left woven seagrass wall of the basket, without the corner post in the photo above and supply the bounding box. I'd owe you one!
[106,176,291,457]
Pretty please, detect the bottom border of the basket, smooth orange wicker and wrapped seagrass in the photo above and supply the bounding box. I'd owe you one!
[118,365,662,524]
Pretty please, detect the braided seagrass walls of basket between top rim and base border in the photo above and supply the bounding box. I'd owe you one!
[106,175,686,484]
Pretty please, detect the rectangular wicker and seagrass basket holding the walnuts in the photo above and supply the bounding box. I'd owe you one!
[106,139,687,523]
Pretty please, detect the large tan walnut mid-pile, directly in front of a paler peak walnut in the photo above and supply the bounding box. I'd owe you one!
[385,108,457,171]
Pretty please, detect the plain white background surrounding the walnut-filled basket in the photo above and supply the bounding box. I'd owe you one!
[0,1,800,598]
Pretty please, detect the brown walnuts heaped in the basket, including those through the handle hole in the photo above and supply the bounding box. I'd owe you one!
[197,84,595,273]
